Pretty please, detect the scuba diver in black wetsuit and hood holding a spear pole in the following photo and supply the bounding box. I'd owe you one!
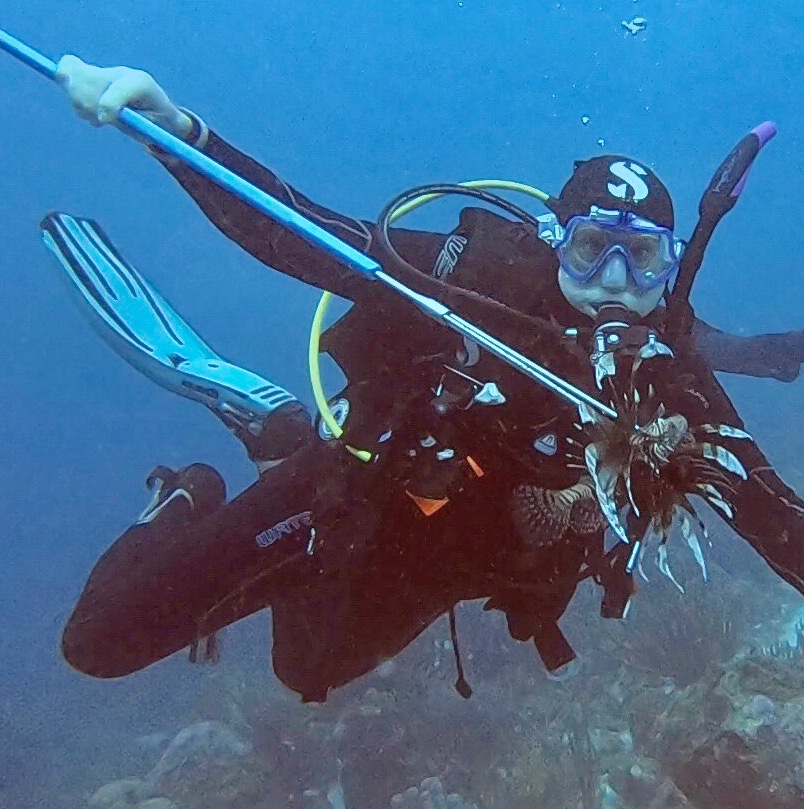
[43,56,804,701]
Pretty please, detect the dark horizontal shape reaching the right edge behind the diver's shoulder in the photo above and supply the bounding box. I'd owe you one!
[693,319,804,382]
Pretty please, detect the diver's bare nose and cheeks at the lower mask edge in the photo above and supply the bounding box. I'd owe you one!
[558,253,665,318]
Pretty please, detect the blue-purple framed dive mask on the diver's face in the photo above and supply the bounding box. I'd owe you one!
[539,206,684,290]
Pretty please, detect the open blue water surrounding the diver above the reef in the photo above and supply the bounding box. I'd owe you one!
[0,0,804,806]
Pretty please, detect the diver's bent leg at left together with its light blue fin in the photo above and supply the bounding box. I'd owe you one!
[42,213,336,677]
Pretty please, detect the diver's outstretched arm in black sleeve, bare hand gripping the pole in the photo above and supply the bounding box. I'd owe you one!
[57,56,445,300]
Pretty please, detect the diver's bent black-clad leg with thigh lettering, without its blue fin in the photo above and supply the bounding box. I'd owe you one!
[63,439,332,678]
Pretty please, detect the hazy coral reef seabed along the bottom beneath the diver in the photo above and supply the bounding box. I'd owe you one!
[83,576,804,809]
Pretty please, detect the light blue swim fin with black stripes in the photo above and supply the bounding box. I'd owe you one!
[41,213,298,435]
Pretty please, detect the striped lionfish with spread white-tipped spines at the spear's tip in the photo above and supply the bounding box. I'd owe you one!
[512,348,752,592]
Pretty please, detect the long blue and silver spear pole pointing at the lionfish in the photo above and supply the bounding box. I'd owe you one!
[0,29,617,419]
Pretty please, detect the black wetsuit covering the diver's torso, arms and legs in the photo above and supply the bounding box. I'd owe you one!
[64,133,804,699]
